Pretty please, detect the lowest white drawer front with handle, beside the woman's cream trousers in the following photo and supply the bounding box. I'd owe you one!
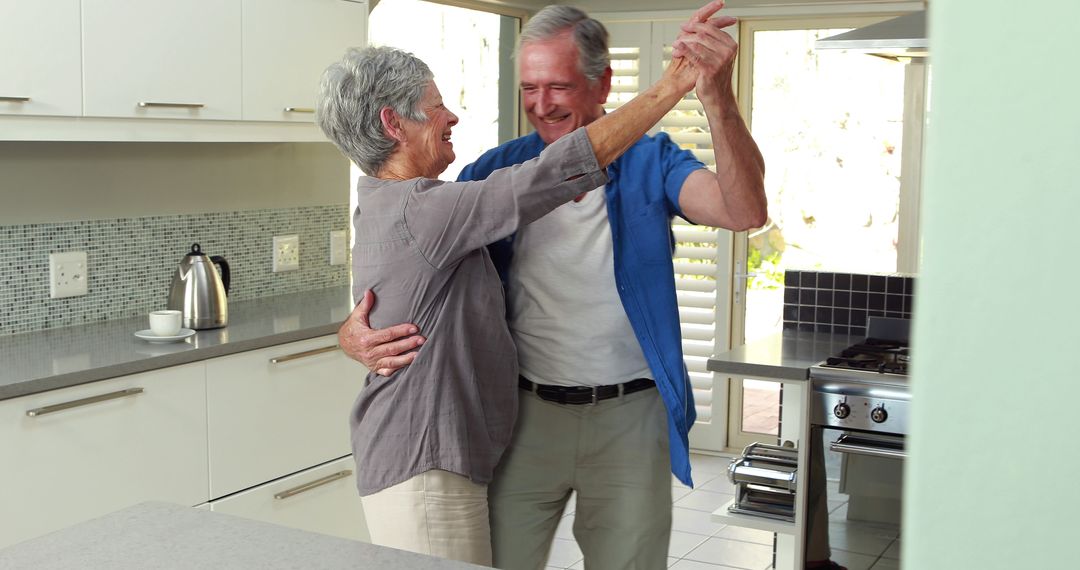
[211,456,370,542]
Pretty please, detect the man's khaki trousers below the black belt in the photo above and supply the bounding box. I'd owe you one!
[489,389,672,570]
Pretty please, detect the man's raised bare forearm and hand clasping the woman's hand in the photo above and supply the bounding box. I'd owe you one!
[673,3,768,231]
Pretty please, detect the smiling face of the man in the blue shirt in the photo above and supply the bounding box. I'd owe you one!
[519,32,611,144]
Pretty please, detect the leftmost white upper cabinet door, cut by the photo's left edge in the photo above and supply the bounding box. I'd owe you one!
[0,0,82,116]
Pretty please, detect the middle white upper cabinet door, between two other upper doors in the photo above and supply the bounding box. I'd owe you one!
[82,0,241,120]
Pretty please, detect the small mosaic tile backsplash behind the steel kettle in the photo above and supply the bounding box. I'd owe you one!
[0,204,350,336]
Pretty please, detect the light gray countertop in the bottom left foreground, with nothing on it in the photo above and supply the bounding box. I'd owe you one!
[0,503,481,570]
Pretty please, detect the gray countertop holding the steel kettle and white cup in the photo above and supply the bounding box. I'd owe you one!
[0,286,352,399]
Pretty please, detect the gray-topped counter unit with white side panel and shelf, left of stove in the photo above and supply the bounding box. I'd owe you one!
[707,330,858,570]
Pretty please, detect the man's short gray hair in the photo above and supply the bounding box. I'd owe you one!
[521,5,611,82]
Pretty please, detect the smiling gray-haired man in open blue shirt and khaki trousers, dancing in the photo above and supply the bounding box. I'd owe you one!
[339,2,766,570]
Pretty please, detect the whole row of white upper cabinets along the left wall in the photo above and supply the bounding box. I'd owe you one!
[0,0,368,141]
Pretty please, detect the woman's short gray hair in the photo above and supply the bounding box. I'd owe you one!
[315,46,433,176]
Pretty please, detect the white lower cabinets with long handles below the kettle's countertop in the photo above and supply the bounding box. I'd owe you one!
[0,336,367,547]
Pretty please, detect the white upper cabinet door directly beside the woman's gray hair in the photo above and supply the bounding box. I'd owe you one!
[243,0,367,122]
